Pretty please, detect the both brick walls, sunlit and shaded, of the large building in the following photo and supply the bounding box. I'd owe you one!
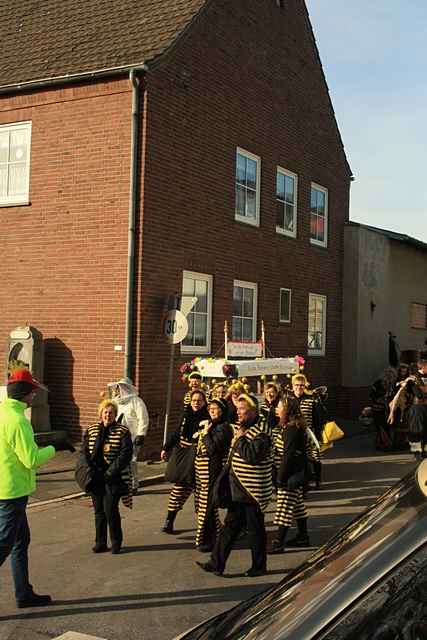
[0,0,349,455]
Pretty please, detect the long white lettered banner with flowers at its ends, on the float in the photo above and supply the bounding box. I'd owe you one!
[196,358,299,378]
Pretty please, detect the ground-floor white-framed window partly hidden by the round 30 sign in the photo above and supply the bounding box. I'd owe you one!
[181,271,212,353]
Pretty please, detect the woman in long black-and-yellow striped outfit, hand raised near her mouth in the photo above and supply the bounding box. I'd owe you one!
[195,398,233,552]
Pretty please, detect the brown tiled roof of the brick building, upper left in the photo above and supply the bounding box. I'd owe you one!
[0,0,209,87]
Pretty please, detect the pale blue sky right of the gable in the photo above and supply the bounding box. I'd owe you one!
[306,0,427,242]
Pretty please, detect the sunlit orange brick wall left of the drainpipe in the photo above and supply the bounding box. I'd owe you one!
[0,80,131,434]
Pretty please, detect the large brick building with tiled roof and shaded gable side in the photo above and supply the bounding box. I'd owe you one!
[0,0,351,451]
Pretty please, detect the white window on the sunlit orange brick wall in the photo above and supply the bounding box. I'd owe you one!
[0,122,31,205]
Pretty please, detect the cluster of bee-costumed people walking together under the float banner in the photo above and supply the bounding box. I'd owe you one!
[161,372,326,576]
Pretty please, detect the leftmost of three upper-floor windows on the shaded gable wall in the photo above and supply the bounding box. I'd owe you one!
[235,149,261,227]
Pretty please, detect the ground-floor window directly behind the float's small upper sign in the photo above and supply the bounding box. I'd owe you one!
[231,280,257,340]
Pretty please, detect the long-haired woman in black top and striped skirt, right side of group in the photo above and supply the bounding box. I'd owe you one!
[270,398,310,554]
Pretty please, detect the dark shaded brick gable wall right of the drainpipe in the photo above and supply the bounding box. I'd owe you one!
[138,0,349,456]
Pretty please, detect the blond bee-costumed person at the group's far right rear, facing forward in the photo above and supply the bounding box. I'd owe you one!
[292,373,323,488]
